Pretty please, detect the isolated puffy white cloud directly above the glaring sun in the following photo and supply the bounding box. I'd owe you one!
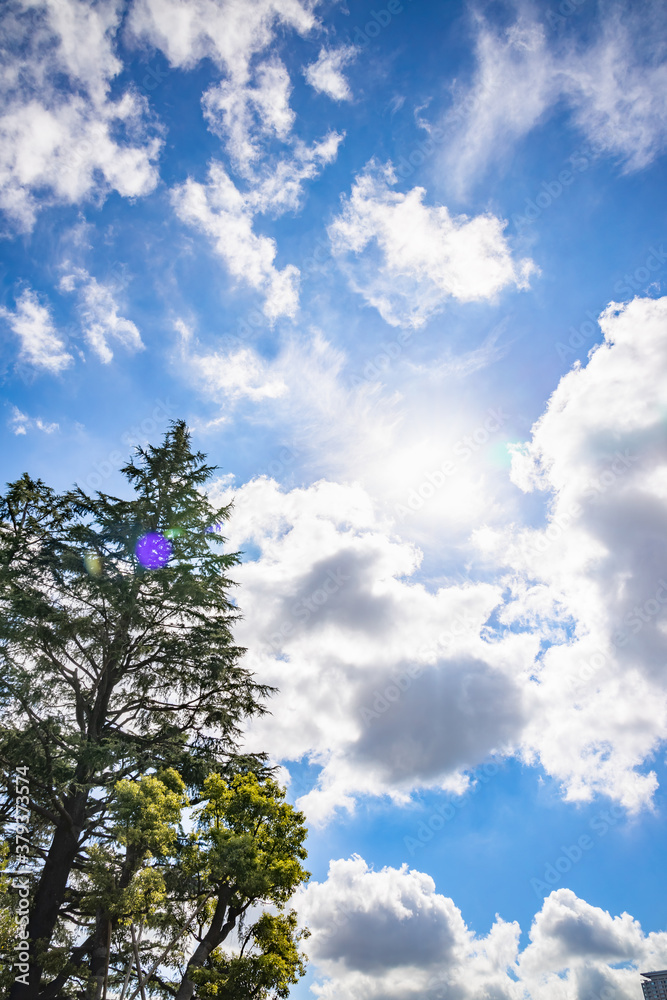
[329,161,535,327]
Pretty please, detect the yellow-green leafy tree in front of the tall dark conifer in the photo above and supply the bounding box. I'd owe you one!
[76,770,309,1000]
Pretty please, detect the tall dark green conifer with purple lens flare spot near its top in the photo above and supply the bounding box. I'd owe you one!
[0,422,276,1000]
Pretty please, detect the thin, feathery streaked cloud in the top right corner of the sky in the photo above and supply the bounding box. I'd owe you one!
[446,2,667,188]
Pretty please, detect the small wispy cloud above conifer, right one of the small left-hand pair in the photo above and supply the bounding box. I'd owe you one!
[60,267,144,364]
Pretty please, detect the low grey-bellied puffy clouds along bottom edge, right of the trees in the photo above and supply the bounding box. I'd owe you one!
[297,855,667,1000]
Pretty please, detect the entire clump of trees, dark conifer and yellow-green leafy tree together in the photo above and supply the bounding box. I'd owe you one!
[0,422,308,1000]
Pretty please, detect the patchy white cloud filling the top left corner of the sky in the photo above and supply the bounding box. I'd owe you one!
[0,0,161,231]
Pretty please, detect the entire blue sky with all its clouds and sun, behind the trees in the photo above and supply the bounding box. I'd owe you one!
[0,0,667,1000]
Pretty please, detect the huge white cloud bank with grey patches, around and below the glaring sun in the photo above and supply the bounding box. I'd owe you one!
[194,299,667,822]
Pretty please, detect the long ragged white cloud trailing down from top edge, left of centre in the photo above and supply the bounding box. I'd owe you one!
[134,0,343,322]
